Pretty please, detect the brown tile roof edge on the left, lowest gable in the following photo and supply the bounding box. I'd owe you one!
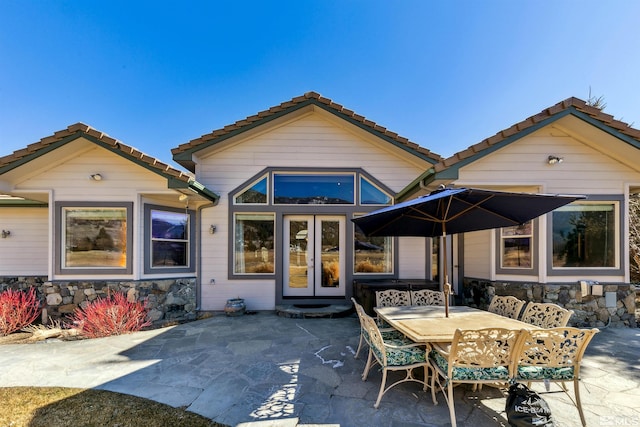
[0,123,219,202]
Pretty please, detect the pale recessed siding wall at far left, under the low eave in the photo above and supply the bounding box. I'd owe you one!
[0,208,49,276]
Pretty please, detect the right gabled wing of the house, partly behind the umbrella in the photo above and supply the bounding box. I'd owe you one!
[397,98,640,325]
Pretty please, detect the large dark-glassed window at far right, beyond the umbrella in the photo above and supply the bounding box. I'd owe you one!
[552,202,619,268]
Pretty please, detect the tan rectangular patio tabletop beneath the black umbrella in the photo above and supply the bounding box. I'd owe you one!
[374,306,540,344]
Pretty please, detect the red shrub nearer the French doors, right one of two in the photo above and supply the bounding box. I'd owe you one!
[71,292,151,338]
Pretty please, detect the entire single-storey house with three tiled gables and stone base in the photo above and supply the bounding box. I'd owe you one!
[0,92,640,324]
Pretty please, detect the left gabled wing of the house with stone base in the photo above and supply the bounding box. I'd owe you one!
[0,123,218,320]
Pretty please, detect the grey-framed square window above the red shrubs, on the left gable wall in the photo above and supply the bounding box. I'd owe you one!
[55,202,132,274]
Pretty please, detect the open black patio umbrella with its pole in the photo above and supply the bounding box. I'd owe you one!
[352,188,585,317]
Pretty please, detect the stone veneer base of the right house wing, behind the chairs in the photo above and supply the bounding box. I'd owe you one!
[459,278,640,328]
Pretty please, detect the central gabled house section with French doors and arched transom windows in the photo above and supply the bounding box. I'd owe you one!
[173,92,442,310]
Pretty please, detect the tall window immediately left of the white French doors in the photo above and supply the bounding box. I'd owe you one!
[233,213,275,274]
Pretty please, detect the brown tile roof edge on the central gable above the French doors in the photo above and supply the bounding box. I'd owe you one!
[171,92,443,163]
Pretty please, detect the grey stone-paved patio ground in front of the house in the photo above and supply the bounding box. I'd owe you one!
[0,312,640,427]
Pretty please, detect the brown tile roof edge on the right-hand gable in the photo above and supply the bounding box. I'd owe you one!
[433,97,640,173]
